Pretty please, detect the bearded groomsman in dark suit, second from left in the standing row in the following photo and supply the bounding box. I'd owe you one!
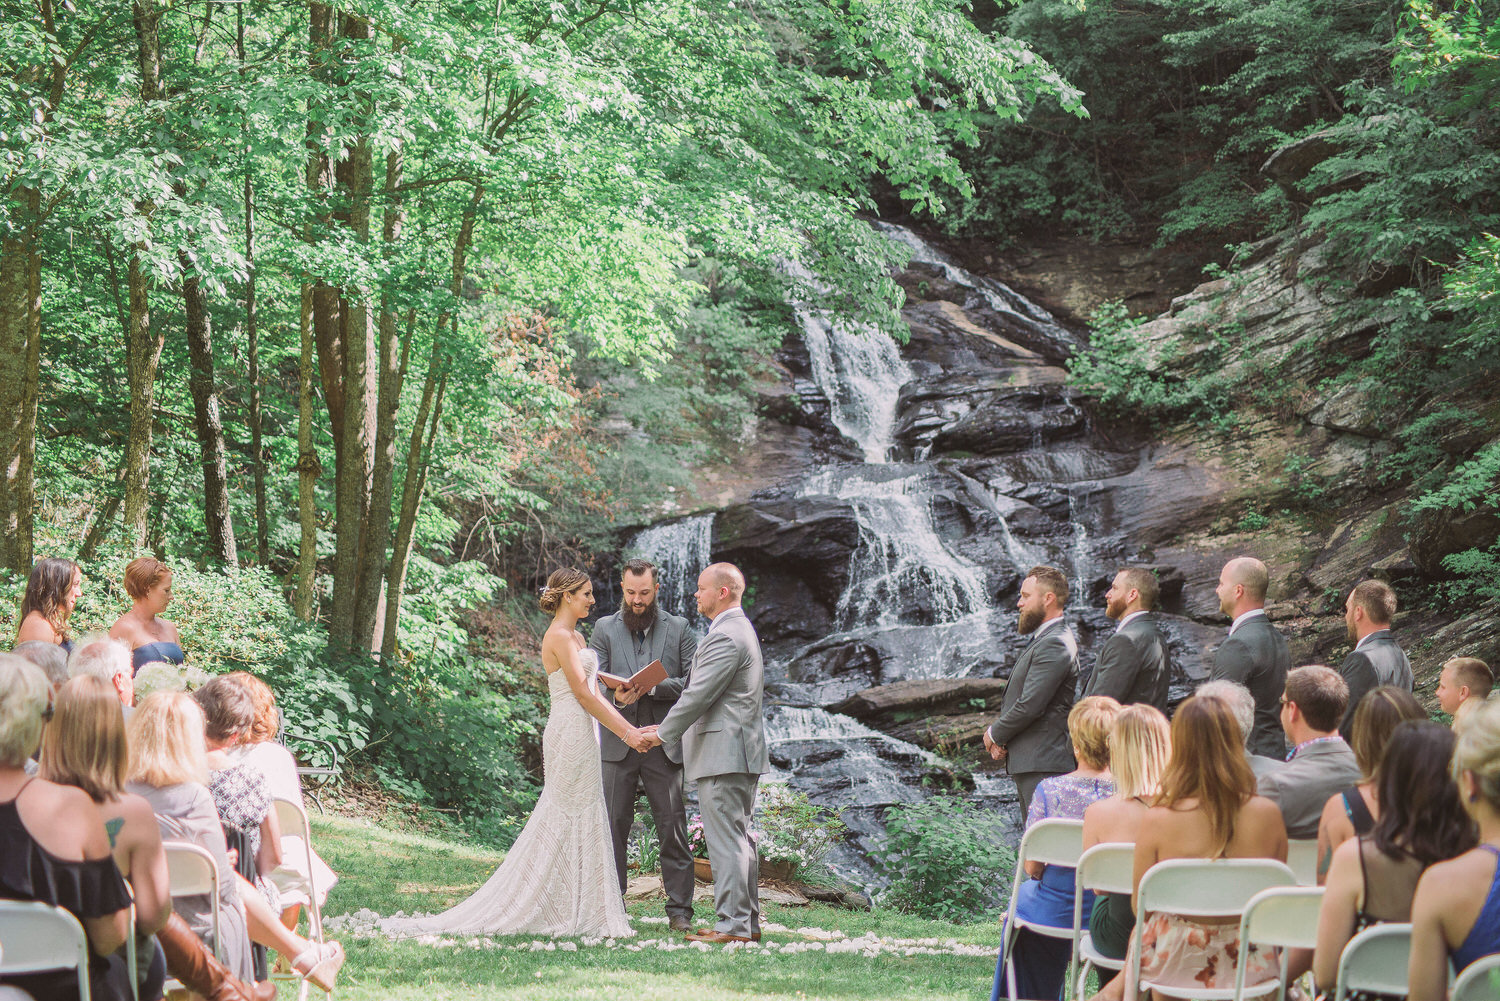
[1083,567,1172,714]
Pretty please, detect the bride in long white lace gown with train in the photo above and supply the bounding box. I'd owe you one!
[381,569,651,938]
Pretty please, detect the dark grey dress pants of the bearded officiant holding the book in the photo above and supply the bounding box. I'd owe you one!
[600,747,693,918]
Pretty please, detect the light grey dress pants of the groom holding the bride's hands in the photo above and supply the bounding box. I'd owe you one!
[698,771,761,938]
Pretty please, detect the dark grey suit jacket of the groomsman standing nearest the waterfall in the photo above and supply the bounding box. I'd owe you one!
[990,621,1079,774]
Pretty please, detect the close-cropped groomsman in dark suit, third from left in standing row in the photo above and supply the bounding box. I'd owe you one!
[1209,557,1292,759]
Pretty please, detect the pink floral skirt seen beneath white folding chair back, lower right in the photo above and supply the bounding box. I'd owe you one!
[1140,912,1281,989]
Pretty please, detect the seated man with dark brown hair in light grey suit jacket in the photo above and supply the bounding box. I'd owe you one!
[1260,665,1359,837]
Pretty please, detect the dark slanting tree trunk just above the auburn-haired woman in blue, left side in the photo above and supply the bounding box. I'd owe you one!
[179,254,240,566]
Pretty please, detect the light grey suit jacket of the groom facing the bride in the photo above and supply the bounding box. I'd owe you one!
[657,606,771,780]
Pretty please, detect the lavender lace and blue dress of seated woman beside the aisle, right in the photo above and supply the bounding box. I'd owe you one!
[990,774,1115,1001]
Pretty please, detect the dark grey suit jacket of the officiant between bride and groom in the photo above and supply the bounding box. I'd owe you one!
[588,608,698,764]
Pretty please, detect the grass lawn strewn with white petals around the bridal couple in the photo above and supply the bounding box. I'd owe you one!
[282,816,999,1001]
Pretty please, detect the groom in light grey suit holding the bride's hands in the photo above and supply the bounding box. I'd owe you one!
[647,563,771,942]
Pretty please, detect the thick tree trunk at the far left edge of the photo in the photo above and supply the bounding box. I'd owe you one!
[0,188,42,573]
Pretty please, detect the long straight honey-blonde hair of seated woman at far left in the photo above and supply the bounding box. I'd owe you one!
[41,675,131,803]
